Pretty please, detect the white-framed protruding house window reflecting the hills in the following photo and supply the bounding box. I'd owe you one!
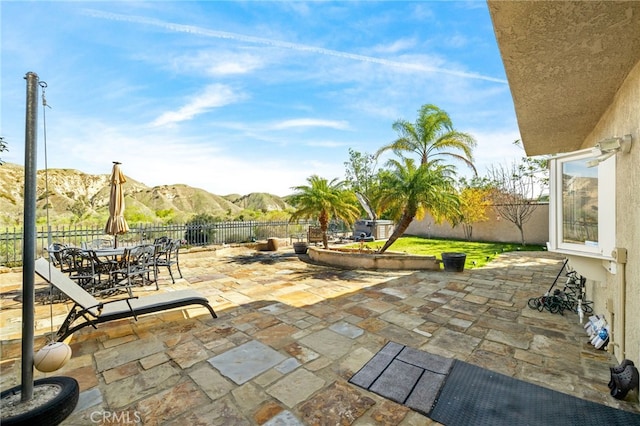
[549,149,616,258]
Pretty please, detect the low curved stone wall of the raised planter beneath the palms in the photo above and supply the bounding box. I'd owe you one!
[308,247,440,271]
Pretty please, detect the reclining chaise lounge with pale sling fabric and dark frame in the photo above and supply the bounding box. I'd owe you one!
[35,257,218,342]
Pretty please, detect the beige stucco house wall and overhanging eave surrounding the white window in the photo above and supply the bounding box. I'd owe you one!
[487,0,640,364]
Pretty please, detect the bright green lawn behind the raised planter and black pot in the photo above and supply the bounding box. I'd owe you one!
[350,237,545,269]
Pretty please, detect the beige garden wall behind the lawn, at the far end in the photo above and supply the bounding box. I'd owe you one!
[405,204,549,245]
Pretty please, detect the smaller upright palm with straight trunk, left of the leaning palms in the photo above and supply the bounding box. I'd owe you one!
[290,175,359,249]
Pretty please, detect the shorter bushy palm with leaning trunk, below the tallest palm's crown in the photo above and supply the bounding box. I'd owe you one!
[377,158,459,253]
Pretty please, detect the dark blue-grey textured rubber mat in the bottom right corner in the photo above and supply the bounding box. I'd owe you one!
[429,360,640,426]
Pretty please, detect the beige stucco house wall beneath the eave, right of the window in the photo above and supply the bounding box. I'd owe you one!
[582,62,640,362]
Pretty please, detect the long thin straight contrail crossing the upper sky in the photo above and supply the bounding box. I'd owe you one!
[84,9,507,84]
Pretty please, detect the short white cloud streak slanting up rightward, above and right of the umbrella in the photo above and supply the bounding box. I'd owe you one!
[151,84,243,127]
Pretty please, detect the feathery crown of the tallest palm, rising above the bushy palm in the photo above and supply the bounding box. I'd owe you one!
[376,104,477,173]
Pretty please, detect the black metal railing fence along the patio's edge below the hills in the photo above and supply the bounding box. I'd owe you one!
[0,221,342,266]
